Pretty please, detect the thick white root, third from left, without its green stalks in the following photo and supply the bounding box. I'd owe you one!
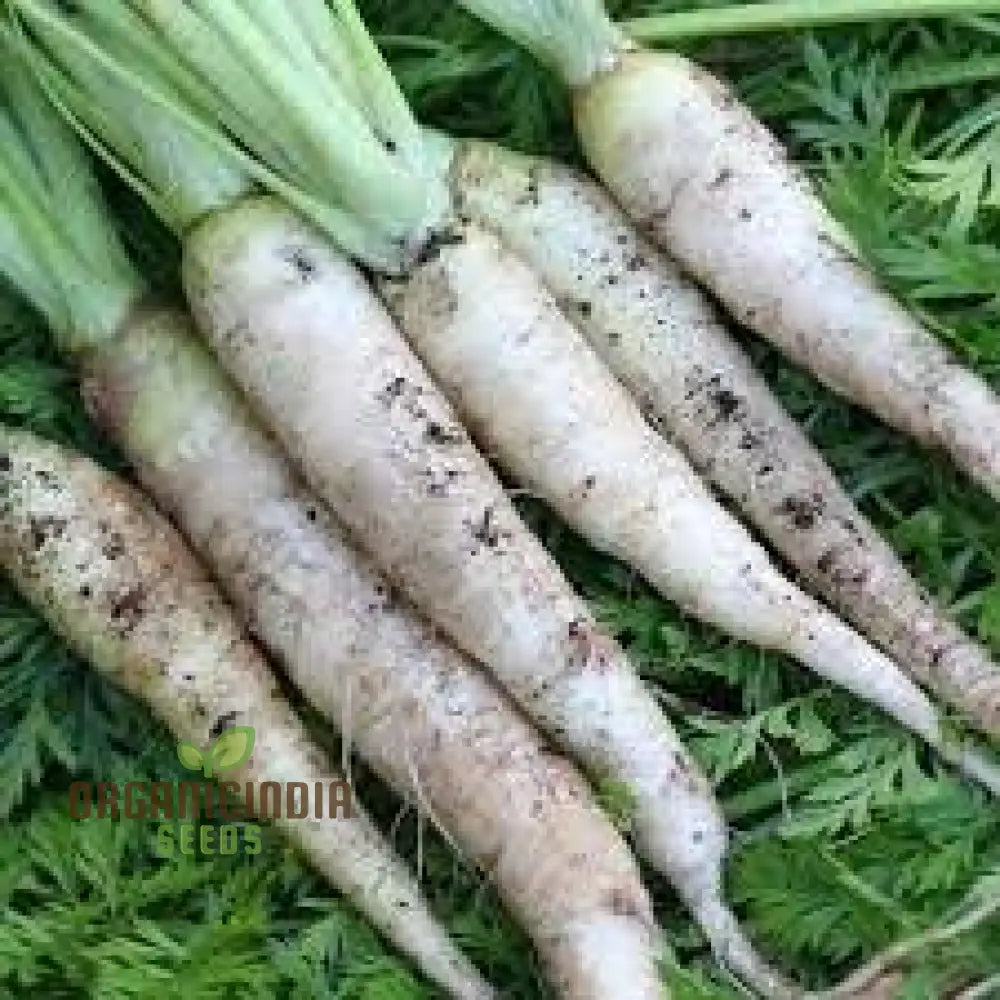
[184,199,744,995]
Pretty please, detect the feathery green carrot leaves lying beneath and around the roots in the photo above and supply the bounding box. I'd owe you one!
[0,0,1000,1000]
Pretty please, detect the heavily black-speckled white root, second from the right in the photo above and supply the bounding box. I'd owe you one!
[453,142,1000,735]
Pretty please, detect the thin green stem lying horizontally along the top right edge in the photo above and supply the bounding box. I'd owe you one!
[625,0,1000,42]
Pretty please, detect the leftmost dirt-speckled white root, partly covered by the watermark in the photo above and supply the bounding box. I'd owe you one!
[0,428,493,1000]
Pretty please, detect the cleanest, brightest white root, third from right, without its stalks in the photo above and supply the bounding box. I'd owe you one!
[383,219,1000,793]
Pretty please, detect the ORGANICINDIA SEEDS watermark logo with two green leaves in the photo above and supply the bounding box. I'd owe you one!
[69,726,354,857]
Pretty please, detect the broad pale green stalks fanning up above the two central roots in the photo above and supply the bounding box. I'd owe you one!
[11,0,449,270]
